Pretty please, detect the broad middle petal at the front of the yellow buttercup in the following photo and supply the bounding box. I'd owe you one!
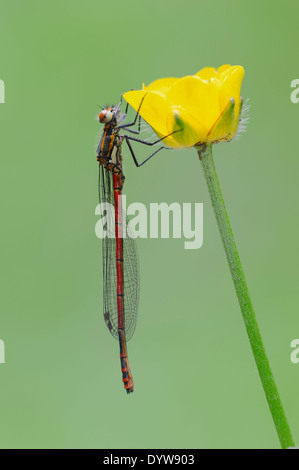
[166,75,220,132]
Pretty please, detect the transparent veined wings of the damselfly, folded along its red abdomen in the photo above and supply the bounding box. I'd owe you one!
[99,165,139,341]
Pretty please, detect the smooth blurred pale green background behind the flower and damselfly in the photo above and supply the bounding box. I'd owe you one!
[0,0,299,449]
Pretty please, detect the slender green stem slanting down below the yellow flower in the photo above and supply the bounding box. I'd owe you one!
[196,145,295,449]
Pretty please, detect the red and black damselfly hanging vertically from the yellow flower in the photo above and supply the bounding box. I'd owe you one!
[97,95,177,393]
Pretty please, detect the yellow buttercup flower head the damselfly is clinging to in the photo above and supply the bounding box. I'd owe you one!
[123,65,244,148]
